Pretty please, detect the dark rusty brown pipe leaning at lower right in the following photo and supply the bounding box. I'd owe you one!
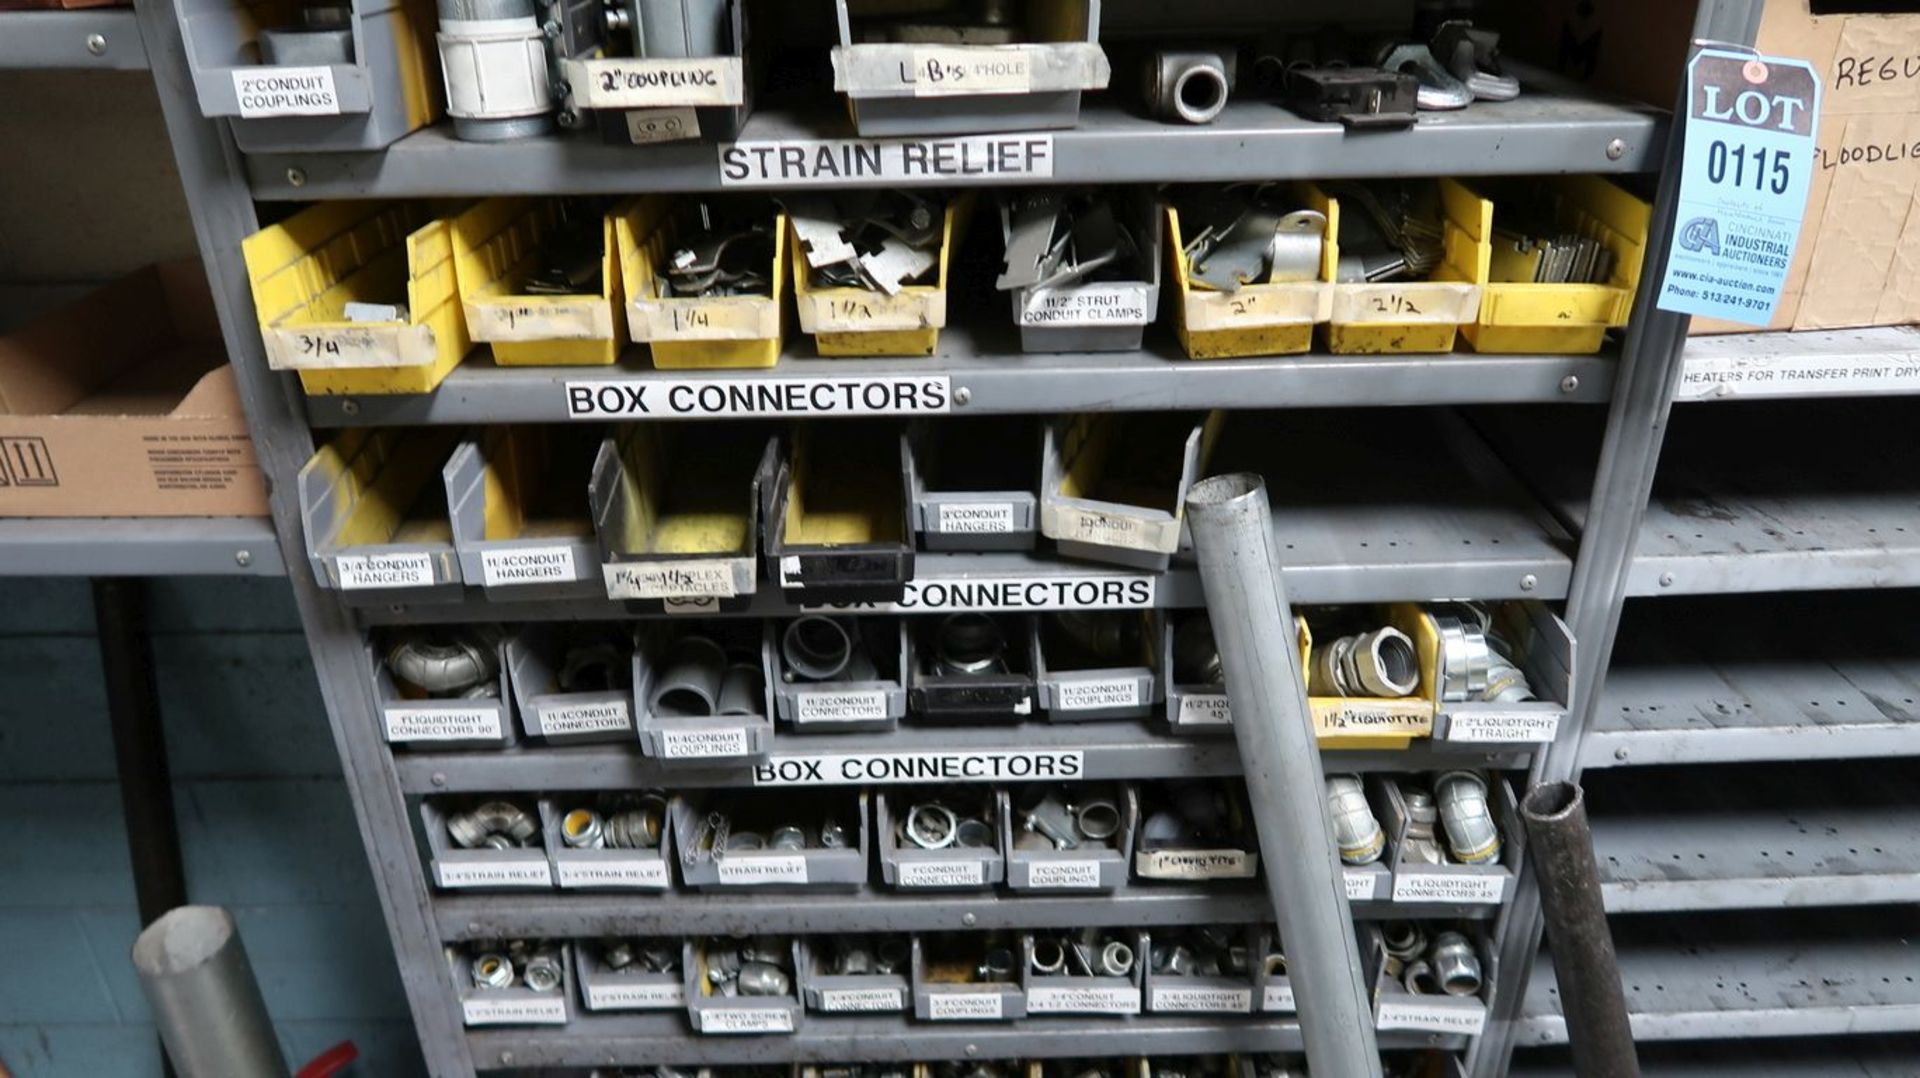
[1521,782,1640,1078]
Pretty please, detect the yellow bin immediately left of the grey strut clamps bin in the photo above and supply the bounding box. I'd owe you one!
[789,192,973,357]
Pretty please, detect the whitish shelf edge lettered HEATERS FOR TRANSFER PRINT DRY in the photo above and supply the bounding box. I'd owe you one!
[1674,327,1920,402]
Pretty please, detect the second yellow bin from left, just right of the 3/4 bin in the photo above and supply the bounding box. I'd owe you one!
[453,198,632,367]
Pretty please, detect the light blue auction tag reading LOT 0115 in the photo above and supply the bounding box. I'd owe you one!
[1659,48,1820,325]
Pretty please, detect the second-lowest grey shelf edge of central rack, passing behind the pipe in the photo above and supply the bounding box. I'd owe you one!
[434,882,1501,940]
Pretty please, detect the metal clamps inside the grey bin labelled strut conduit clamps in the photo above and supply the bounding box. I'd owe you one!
[995,188,1148,292]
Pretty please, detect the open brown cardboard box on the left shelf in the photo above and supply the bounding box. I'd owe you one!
[0,263,267,517]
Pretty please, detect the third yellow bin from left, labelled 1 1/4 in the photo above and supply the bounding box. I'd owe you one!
[620,196,787,371]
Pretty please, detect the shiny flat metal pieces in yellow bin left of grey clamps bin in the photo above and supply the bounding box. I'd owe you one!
[785,190,947,296]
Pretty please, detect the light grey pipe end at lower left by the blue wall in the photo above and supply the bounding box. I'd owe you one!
[132,905,288,1078]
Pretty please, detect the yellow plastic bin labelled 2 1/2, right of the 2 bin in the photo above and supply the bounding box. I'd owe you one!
[1304,179,1494,355]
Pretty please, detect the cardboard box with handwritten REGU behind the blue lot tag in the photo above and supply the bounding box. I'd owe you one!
[1490,0,1920,332]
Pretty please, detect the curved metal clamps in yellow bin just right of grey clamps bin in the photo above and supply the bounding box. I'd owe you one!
[1179,183,1327,292]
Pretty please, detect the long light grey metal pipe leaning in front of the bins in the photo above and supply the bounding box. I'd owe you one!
[1187,473,1380,1078]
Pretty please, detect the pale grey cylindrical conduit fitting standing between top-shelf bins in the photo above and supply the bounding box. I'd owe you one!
[436,0,553,142]
